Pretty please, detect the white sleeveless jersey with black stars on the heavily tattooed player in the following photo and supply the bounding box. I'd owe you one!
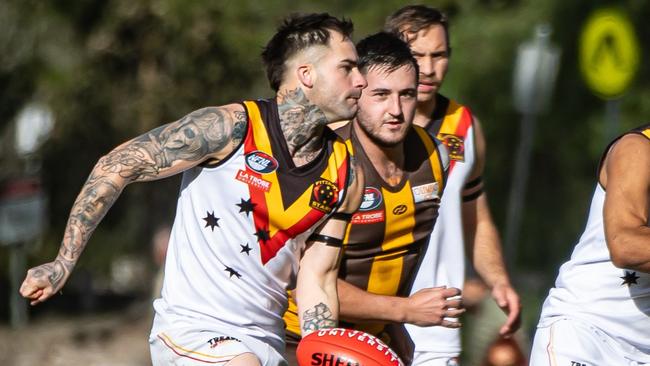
[152,99,349,354]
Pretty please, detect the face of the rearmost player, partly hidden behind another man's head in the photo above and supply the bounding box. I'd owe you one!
[407,24,449,103]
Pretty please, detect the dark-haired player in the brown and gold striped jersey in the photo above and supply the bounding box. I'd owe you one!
[285,33,463,363]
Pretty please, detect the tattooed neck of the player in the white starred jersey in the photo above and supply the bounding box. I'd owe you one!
[278,88,327,161]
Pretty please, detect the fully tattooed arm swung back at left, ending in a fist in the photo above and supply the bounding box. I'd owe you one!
[20,104,247,305]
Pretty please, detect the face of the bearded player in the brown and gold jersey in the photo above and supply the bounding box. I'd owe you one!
[355,66,417,147]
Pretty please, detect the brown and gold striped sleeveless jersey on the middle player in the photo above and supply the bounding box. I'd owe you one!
[285,123,446,362]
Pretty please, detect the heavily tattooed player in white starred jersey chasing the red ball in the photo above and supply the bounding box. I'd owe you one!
[21,14,366,365]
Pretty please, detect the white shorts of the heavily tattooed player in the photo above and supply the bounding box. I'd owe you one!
[150,329,259,366]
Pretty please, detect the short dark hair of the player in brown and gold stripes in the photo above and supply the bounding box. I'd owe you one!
[357,32,419,77]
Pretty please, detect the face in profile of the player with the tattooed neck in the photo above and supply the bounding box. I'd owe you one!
[309,32,367,122]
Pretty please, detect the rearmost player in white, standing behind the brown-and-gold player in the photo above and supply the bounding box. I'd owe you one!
[384,5,521,365]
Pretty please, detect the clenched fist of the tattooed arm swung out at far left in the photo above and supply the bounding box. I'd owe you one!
[20,260,68,305]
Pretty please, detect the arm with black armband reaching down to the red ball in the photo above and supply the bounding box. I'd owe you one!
[295,159,364,336]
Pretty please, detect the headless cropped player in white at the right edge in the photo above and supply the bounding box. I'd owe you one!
[530,125,650,366]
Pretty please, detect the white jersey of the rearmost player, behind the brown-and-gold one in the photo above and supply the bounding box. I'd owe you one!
[405,94,476,357]
